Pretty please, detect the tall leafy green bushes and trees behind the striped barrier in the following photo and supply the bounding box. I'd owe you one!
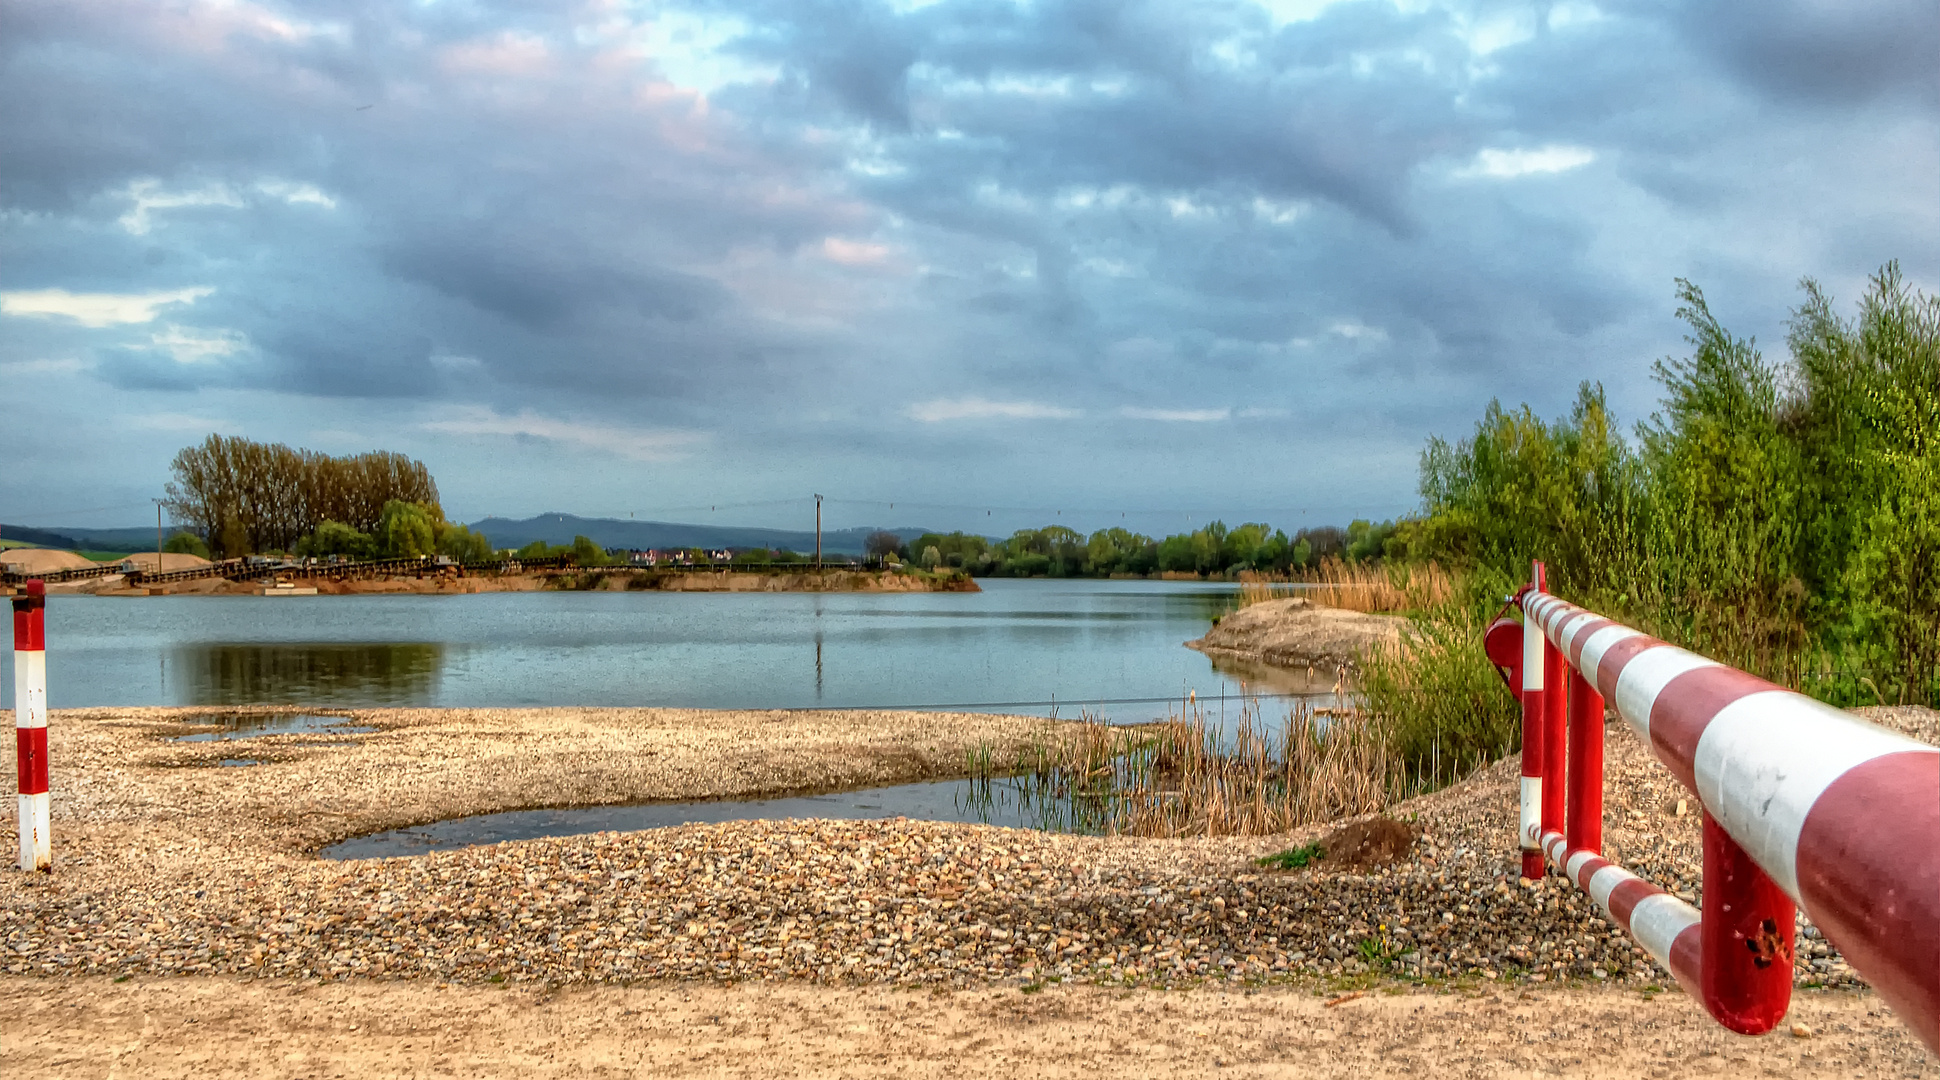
[1397,264,1940,706]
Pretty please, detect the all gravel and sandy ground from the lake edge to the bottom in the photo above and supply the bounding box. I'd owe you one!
[0,708,1940,1078]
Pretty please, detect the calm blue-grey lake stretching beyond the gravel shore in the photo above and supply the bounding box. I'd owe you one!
[11,580,1325,721]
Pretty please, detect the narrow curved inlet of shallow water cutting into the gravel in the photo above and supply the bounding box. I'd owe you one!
[320,779,1096,859]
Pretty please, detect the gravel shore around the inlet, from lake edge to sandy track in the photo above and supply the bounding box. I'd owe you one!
[0,710,1940,1008]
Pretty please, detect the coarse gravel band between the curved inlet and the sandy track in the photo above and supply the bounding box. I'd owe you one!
[0,710,1940,987]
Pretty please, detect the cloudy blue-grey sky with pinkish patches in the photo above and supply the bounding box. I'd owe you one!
[0,0,1940,531]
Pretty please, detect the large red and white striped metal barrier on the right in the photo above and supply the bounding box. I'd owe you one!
[1519,580,1940,1051]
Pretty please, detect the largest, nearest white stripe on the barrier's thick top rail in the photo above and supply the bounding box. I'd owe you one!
[1683,690,1932,900]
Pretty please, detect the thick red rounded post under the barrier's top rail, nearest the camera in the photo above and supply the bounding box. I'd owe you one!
[1699,810,1798,1035]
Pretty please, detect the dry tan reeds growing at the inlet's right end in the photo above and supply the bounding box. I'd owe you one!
[970,698,1412,838]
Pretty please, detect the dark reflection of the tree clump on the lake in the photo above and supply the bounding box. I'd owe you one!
[173,642,444,706]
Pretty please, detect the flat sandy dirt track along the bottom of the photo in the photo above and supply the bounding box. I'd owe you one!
[0,977,1940,1078]
